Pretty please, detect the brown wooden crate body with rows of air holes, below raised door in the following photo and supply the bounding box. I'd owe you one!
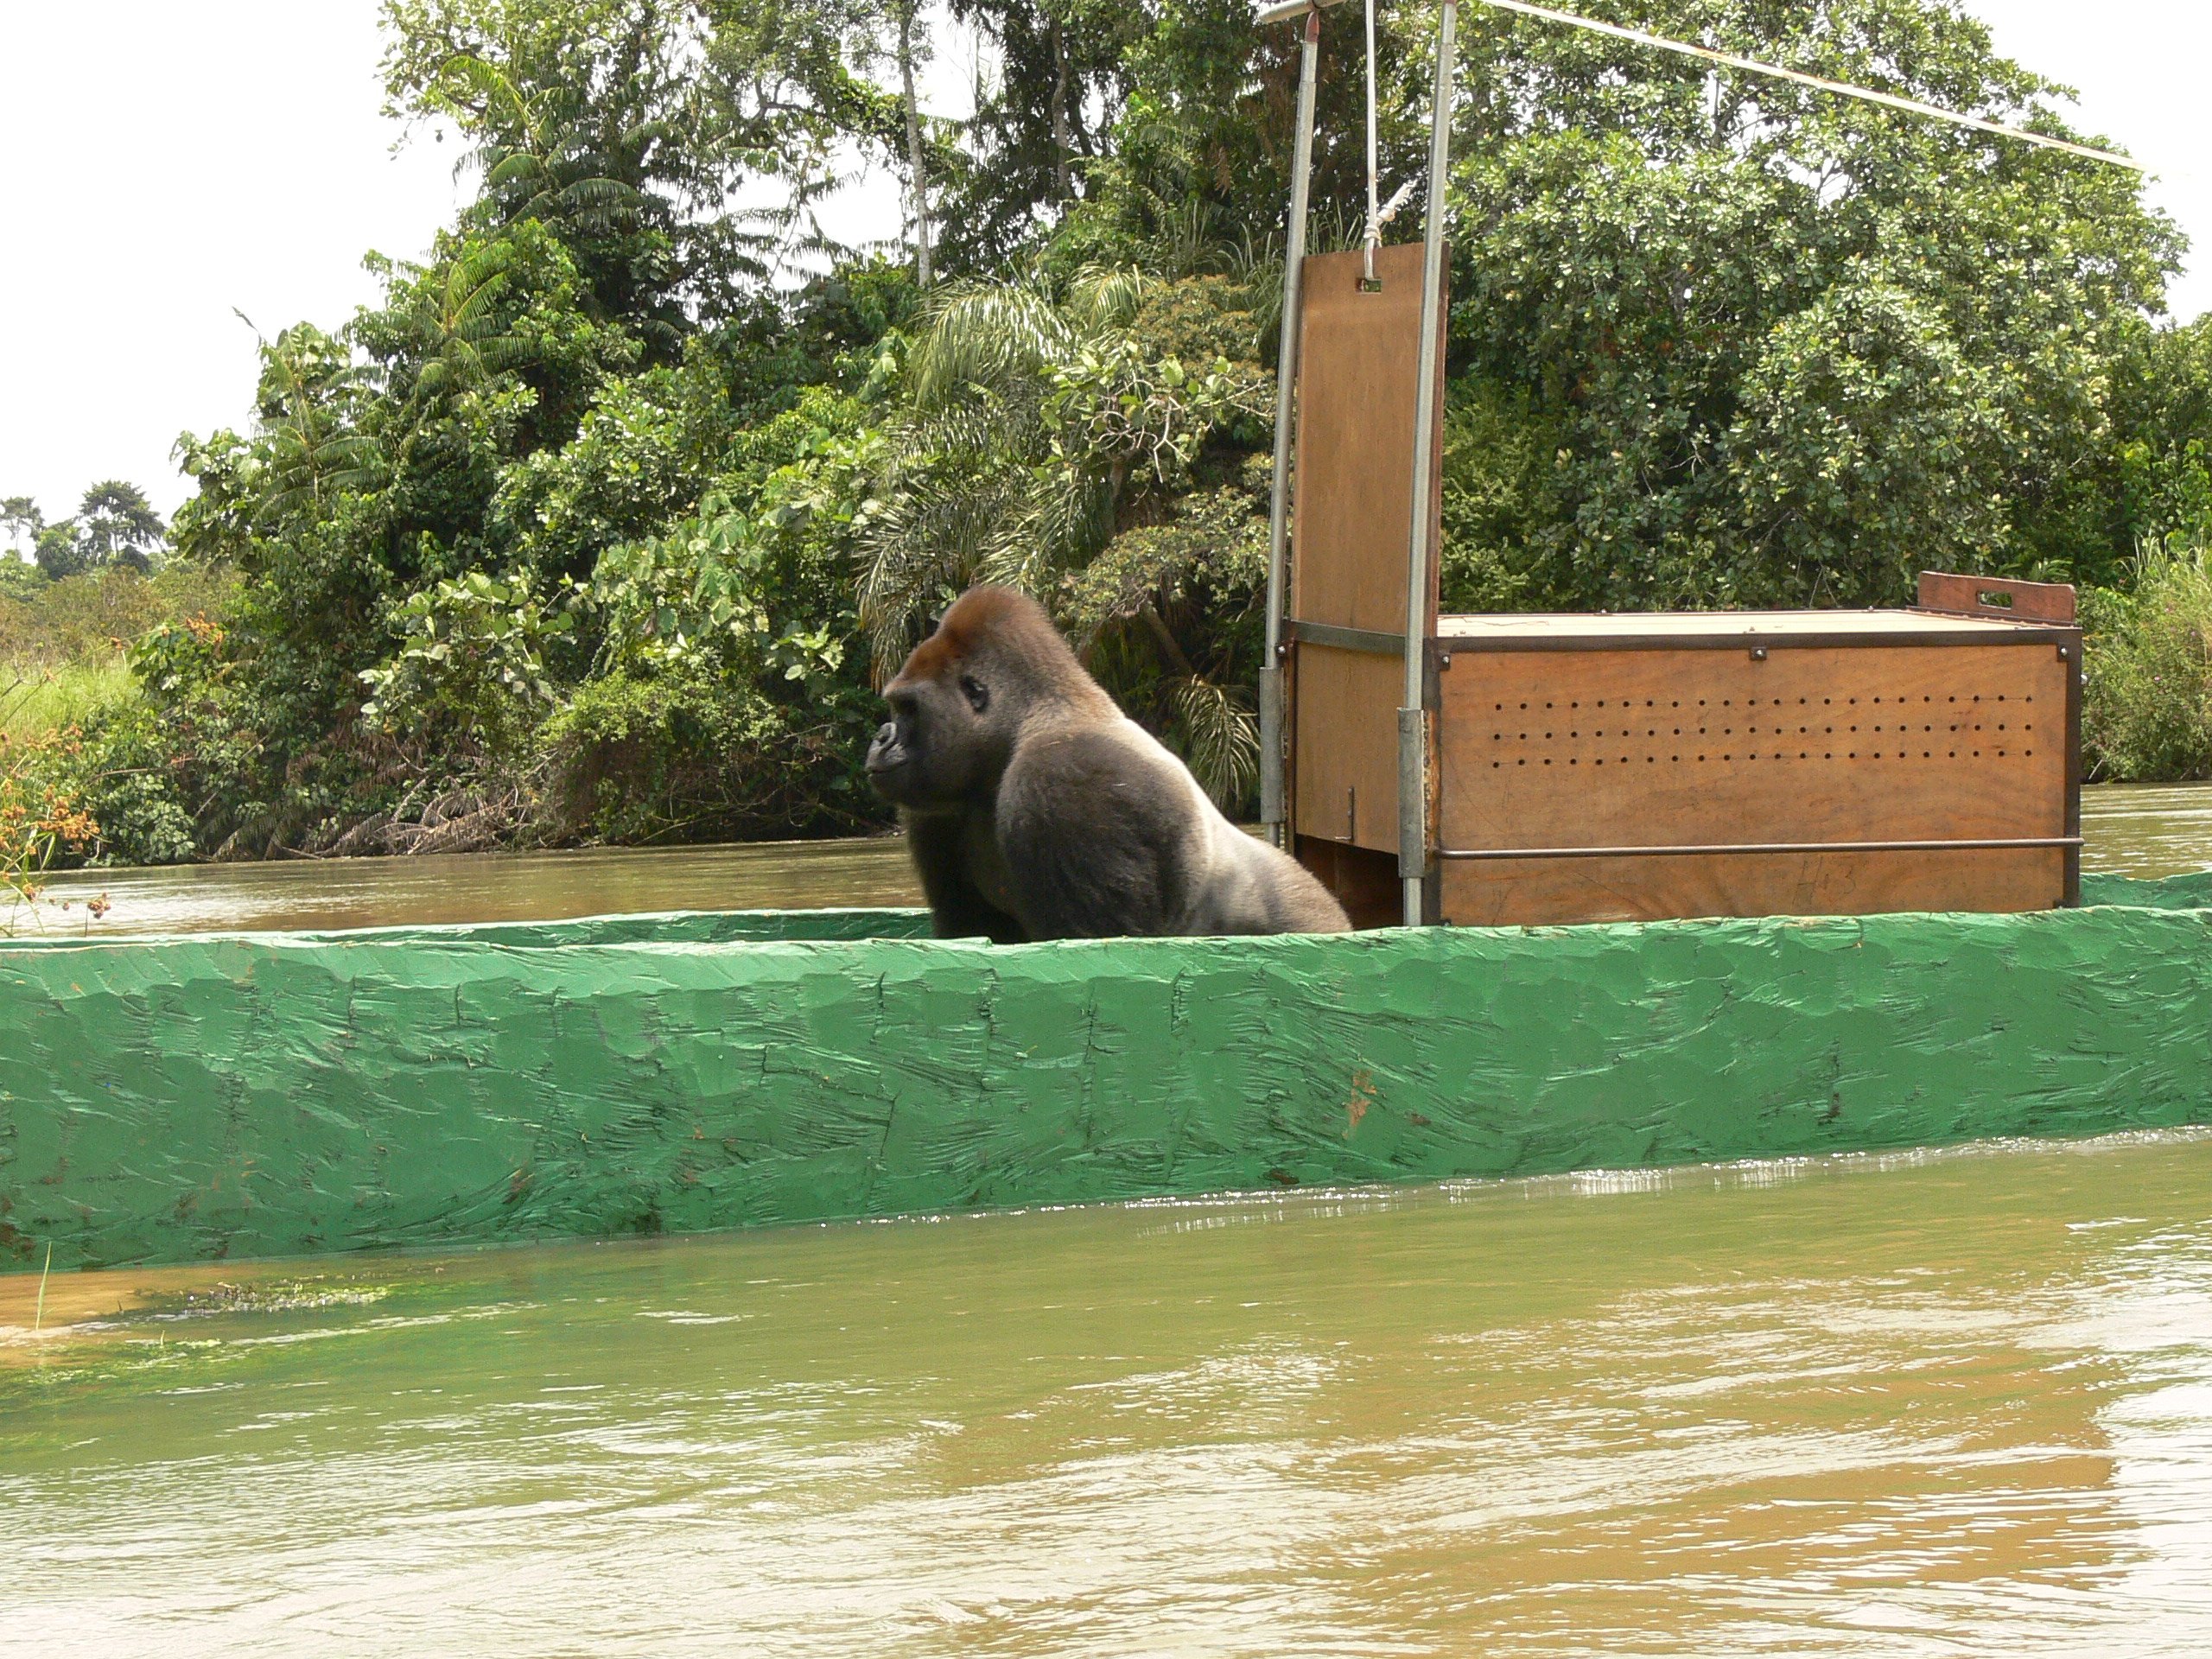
[1292,575,2082,925]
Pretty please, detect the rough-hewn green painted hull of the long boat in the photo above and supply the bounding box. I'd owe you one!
[0,876,2212,1268]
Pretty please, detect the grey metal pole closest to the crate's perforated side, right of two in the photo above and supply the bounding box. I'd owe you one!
[1398,0,1460,927]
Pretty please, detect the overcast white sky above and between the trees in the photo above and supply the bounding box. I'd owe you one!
[0,0,2212,518]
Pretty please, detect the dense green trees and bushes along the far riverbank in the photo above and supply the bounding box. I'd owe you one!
[0,0,2212,875]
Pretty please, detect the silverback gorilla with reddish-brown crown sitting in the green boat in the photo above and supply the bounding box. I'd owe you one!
[868,588,1351,944]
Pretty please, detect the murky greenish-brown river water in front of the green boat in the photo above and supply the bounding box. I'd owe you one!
[0,1137,2212,1659]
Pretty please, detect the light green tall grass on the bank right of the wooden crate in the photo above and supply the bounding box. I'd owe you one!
[2082,542,2212,783]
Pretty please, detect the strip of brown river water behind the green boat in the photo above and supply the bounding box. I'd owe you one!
[17,783,2212,936]
